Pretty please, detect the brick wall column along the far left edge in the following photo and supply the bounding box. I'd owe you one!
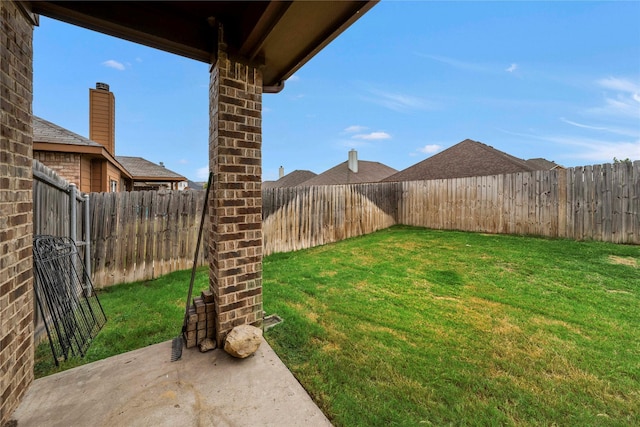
[0,0,35,425]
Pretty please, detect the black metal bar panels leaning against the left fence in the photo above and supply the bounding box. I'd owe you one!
[33,236,107,365]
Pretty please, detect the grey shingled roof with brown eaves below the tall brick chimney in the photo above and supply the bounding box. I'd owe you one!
[32,116,131,179]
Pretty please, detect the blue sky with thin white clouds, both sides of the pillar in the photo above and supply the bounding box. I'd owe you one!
[33,0,640,181]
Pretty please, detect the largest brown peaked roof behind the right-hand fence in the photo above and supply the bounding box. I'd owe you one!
[384,139,552,181]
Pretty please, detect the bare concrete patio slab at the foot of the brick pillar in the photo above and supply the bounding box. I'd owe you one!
[12,339,331,427]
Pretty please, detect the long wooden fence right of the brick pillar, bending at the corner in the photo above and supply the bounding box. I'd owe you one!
[263,161,640,249]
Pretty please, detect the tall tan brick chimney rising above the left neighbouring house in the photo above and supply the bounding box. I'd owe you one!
[89,83,116,156]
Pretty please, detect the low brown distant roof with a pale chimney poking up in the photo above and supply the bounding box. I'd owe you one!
[298,160,397,187]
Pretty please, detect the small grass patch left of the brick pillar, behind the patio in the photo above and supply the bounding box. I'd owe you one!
[34,268,209,378]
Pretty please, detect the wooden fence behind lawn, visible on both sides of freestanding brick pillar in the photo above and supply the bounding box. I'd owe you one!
[84,162,640,287]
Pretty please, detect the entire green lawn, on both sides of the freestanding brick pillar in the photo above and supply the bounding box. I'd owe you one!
[36,227,640,426]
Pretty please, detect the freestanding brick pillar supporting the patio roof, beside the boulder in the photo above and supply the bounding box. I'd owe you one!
[209,35,263,346]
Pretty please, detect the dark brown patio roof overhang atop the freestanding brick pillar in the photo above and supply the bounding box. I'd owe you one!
[31,0,378,92]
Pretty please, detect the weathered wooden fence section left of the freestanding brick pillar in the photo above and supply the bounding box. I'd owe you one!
[90,191,207,287]
